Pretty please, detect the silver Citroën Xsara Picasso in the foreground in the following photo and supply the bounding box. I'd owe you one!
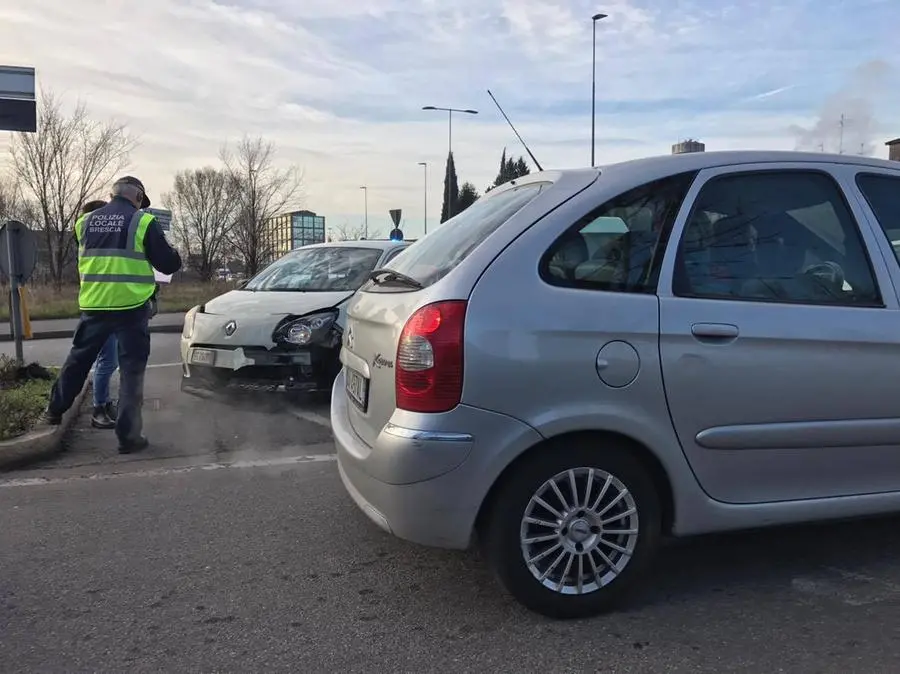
[331,152,900,618]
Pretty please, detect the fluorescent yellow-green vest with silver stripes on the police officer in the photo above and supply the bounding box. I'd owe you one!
[75,211,156,311]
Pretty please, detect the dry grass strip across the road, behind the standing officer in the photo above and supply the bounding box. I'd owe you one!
[0,281,235,321]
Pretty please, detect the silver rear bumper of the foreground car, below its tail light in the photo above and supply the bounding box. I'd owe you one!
[331,372,540,549]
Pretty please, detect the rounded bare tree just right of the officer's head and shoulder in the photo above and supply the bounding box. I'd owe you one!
[163,166,240,281]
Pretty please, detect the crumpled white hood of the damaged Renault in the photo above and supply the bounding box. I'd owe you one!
[192,290,353,347]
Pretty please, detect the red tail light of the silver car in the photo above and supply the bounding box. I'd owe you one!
[395,300,466,412]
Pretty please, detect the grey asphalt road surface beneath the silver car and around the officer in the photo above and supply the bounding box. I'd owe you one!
[0,335,900,674]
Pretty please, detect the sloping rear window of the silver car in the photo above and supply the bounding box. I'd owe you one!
[365,182,551,290]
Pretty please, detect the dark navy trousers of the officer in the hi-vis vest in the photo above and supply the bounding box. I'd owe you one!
[47,303,150,443]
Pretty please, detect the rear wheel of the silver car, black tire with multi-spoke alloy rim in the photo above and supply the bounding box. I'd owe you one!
[479,436,662,619]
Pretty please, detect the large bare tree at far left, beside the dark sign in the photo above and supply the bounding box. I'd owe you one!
[10,90,135,286]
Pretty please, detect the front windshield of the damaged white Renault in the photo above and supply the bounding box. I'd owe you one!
[243,246,382,292]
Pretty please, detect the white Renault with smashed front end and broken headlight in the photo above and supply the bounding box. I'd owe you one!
[181,240,410,393]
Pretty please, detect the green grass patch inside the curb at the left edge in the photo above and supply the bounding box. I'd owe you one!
[0,356,57,440]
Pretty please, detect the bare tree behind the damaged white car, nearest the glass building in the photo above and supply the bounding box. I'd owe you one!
[222,136,303,276]
